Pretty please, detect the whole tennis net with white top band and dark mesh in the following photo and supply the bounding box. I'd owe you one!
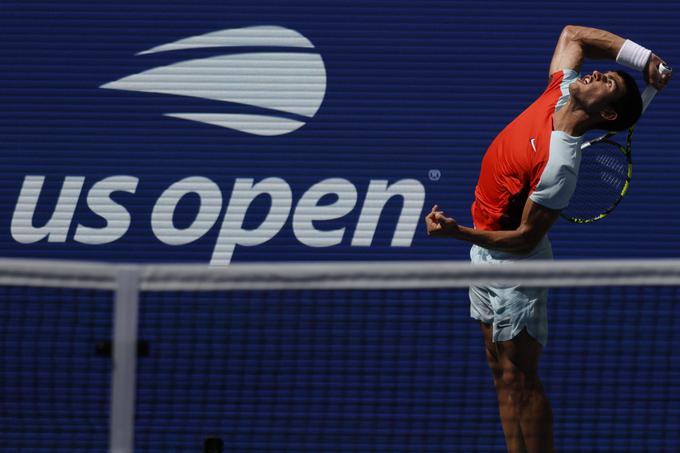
[0,260,680,452]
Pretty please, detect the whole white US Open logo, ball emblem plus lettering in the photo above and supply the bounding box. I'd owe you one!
[10,26,425,265]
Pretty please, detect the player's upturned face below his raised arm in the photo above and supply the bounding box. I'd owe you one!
[569,71,626,113]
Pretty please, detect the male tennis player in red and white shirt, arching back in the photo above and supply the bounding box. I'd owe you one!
[425,26,670,453]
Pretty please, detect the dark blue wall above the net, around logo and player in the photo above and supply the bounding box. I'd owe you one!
[0,1,680,262]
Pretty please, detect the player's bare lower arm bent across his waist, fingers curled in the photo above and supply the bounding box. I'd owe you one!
[425,199,560,255]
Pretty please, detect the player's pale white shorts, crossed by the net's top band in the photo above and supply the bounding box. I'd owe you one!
[470,236,553,346]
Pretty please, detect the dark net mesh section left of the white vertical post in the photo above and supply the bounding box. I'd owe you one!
[0,286,113,452]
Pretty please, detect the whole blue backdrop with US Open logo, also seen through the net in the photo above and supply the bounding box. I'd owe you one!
[0,0,680,452]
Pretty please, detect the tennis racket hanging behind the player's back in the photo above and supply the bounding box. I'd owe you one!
[562,64,672,223]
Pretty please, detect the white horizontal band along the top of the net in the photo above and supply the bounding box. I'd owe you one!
[0,259,680,291]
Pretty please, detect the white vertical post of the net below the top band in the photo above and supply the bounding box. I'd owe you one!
[109,266,140,453]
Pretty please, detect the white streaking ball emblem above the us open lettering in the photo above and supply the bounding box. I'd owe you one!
[100,25,326,136]
